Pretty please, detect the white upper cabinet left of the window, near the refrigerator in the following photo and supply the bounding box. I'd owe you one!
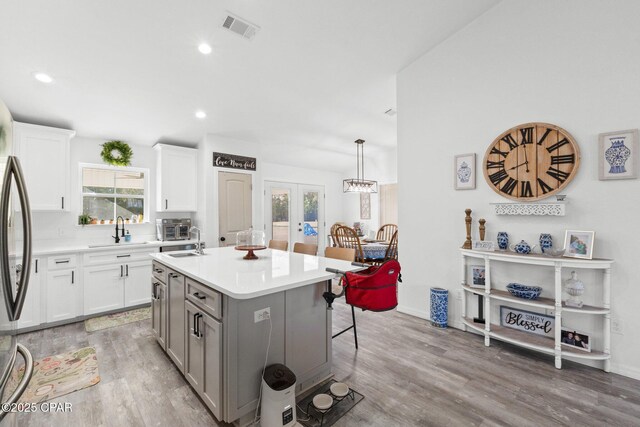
[13,122,75,211]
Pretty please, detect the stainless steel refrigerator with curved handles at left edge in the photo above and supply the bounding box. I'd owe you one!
[0,100,33,426]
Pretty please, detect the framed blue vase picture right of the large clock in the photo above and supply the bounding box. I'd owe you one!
[598,129,640,181]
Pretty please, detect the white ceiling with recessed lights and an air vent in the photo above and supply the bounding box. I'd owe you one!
[0,0,497,171]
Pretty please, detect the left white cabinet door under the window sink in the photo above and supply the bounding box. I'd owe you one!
[84,264,124,315]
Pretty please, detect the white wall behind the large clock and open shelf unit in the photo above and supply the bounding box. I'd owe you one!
[398,0,640,378]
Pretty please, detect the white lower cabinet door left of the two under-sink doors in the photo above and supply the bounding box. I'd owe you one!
[46,268,82,322]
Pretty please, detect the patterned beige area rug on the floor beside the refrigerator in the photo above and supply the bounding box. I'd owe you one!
[5,347,100,403]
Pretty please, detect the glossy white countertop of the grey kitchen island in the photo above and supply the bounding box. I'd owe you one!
[151,247,361,299]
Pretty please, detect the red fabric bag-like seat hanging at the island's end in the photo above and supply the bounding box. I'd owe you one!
[344,259,400,311]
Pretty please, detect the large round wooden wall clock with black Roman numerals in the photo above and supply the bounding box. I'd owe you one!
[482,123,580,201]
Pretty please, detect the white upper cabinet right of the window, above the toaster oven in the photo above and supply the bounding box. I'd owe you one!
[153,144,198,212]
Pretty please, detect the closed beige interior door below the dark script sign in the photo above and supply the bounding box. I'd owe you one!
[218,172,252,246]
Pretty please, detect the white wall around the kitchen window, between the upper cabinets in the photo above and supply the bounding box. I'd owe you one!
[32,137,190,249]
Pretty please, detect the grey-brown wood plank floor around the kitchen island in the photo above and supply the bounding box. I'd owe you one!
[12,302,640,427]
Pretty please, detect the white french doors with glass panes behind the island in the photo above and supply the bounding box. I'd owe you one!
[264,181,325,254]
